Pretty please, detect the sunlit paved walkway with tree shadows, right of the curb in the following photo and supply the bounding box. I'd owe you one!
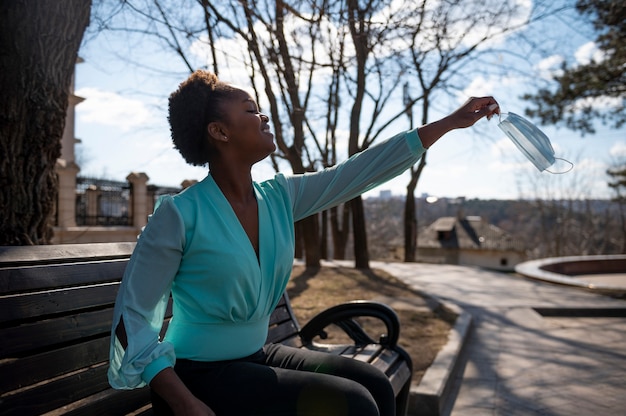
[326,262,626,416]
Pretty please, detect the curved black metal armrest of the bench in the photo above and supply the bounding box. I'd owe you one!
[300,300,400,347]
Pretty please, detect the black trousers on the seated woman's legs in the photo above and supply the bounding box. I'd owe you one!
[152,344,395,416]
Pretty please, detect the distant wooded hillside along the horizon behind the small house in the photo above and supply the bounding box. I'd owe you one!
[364,197,626,259]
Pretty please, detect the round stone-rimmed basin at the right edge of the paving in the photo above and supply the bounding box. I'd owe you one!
[515,255,626,298]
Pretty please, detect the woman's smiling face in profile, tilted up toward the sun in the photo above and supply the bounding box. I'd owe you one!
[217,89,276,164]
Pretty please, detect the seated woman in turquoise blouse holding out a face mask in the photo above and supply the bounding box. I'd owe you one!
[109,71,498,416]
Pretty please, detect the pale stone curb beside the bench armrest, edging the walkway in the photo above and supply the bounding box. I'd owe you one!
[407,302,472,416]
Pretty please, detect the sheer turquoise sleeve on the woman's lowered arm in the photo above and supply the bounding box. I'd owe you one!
[108,198,184,389]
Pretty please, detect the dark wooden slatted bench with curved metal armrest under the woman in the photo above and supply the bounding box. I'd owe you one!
[0,243,412,416]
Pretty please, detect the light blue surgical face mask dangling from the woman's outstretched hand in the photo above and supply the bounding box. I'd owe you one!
[498,113,556,172]
